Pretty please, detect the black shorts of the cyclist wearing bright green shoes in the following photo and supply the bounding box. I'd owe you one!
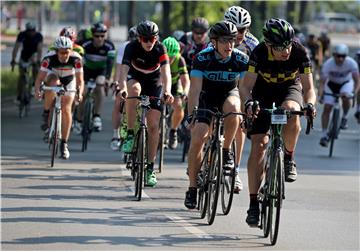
[127,70,163,112]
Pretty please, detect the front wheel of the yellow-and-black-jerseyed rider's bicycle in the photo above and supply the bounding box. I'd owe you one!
[269,149,284,245]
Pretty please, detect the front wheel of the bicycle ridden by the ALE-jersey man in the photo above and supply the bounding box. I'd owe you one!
[207,143,222,225]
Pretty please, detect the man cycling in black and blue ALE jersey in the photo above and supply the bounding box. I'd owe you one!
[184,21,249,209]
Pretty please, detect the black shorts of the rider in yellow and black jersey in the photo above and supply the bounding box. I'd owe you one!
[247,82,303,138]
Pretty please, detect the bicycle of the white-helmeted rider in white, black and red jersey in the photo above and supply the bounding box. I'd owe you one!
[40,84,76,167]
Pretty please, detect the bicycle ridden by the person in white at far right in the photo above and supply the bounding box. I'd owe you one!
[324,93,353,158]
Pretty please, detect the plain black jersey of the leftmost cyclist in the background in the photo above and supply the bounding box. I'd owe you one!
[16,31,43,62]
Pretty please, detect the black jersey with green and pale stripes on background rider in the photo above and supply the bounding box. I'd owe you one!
[82,39,115,79]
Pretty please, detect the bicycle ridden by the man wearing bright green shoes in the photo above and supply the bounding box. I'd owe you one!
[125,95,161,201]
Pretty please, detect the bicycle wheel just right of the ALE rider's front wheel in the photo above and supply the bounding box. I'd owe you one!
[220,141,236,215]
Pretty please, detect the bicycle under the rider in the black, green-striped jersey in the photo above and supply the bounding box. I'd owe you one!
[81,79,96,152]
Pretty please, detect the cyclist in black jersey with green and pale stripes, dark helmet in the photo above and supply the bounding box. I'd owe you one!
[74,23,115,133]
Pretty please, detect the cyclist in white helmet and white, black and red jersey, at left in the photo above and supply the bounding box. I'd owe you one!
[35,36,84,159]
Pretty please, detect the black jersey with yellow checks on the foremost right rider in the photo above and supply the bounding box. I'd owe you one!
[248,41,311,85]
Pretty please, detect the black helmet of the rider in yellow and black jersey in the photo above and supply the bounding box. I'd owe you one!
[263,18,295,46]
